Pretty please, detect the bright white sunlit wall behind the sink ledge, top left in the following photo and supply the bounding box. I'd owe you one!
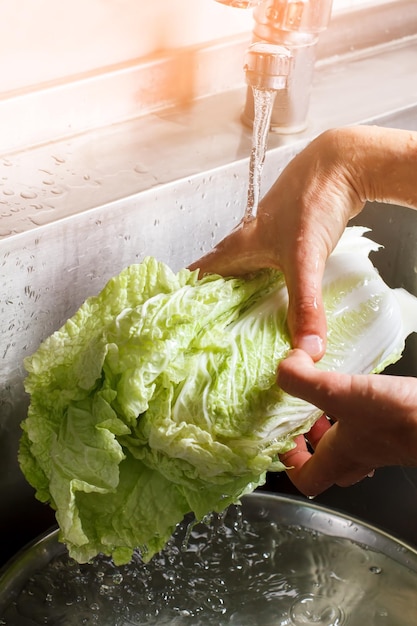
[0,0,378,97]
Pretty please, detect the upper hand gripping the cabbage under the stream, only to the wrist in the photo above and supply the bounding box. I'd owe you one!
[191,131,363,359]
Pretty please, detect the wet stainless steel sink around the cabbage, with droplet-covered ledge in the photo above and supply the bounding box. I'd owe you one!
[0,0,417,565]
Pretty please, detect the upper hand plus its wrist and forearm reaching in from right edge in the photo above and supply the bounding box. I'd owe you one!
[190,126,417,360]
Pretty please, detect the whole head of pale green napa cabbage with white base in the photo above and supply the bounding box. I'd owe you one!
[19,228,417,563]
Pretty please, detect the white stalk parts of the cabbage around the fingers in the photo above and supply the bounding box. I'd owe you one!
[244,227,417,440]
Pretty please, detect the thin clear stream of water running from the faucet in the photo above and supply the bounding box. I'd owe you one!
[244,87,276,221]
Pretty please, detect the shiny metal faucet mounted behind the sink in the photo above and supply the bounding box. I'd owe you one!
[216,0,332,133]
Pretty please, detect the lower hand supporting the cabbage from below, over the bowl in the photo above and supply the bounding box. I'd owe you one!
[278,350,417,496]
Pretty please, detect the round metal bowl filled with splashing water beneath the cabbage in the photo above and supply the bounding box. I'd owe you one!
[0,492,417,626]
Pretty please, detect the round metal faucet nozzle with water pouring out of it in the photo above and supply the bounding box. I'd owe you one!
[244,42,292,91]
